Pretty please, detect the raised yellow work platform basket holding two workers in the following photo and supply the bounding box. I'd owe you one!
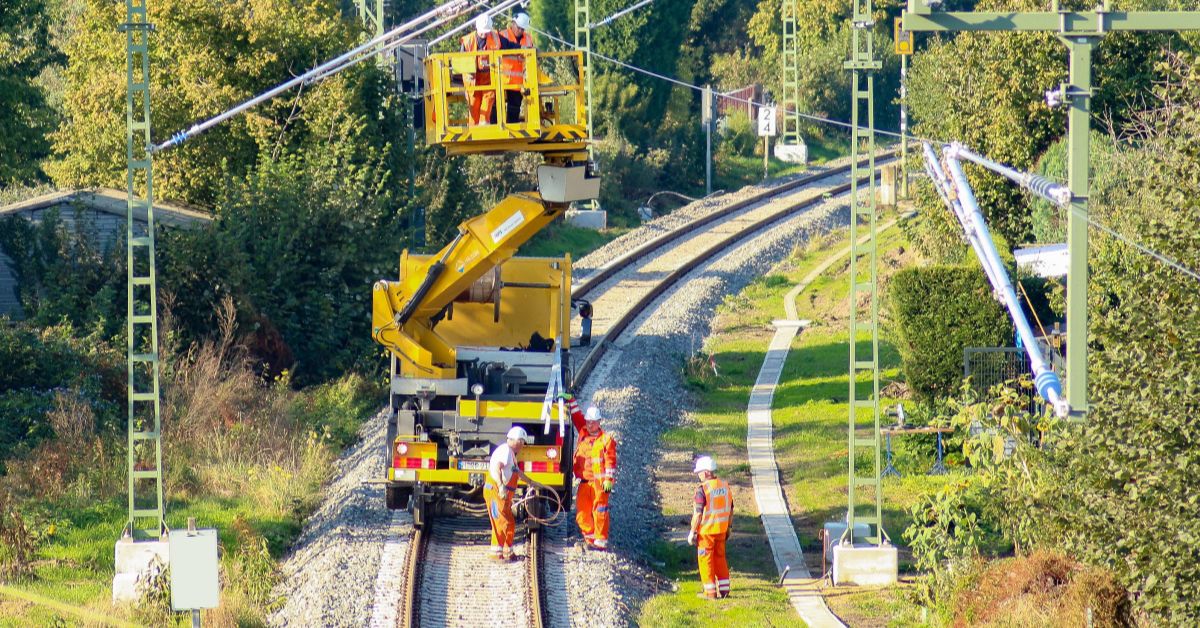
[425,49,589,155]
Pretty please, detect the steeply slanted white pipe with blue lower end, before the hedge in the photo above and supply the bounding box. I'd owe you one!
[947,155,1070,417]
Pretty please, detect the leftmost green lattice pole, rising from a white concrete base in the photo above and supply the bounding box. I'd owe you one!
[122,0,166,539]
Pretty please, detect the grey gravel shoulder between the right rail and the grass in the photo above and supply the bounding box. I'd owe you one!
[566,196,848,627]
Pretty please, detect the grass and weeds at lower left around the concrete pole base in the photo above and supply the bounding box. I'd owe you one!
[0,377,379,627]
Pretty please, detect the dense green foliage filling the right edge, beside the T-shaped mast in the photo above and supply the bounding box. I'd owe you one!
[1054,55,1200,626]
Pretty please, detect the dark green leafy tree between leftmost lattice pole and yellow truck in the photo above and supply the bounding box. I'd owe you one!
[161,151,403,383]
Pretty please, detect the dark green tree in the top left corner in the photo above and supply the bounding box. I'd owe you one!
[0,0,59,187]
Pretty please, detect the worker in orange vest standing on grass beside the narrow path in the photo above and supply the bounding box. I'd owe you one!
[688,456,733,599]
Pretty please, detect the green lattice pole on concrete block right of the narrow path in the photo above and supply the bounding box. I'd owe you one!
[842,0,886,545]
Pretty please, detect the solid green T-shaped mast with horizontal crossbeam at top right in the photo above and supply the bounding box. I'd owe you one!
[904,0,1200,417]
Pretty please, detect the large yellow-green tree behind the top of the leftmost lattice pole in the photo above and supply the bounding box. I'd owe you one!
[47,0,402,205]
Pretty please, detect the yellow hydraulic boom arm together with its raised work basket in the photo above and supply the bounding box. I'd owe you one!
[372,50,599,379]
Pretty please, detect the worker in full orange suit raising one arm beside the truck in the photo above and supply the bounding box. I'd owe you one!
[560,394,617,551]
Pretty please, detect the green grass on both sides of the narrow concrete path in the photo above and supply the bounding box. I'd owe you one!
[640,211,953,626]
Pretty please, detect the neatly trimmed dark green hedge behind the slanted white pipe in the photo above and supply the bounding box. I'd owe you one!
[888,267,1012,399]
